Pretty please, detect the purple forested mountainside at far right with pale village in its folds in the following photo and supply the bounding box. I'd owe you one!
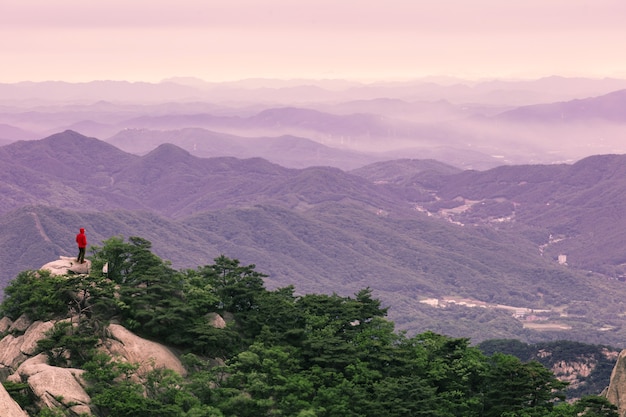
[400,155,626,279]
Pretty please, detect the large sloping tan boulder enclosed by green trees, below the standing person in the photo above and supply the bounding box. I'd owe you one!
[104,324,187,376]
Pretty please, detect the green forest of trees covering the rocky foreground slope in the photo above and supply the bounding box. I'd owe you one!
[0,237,617,417]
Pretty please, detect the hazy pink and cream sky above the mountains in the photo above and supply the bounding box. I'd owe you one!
[0,0,626,82]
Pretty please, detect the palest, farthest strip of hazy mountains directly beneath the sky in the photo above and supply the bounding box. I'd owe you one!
[0,76,626,106]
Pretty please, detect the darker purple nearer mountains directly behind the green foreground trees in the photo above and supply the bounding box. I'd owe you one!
[0,131,626,346]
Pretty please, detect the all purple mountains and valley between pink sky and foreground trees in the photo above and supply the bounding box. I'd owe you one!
[0,78,626,346]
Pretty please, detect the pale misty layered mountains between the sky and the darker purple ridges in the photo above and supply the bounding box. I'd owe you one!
[0,77,626,170]
